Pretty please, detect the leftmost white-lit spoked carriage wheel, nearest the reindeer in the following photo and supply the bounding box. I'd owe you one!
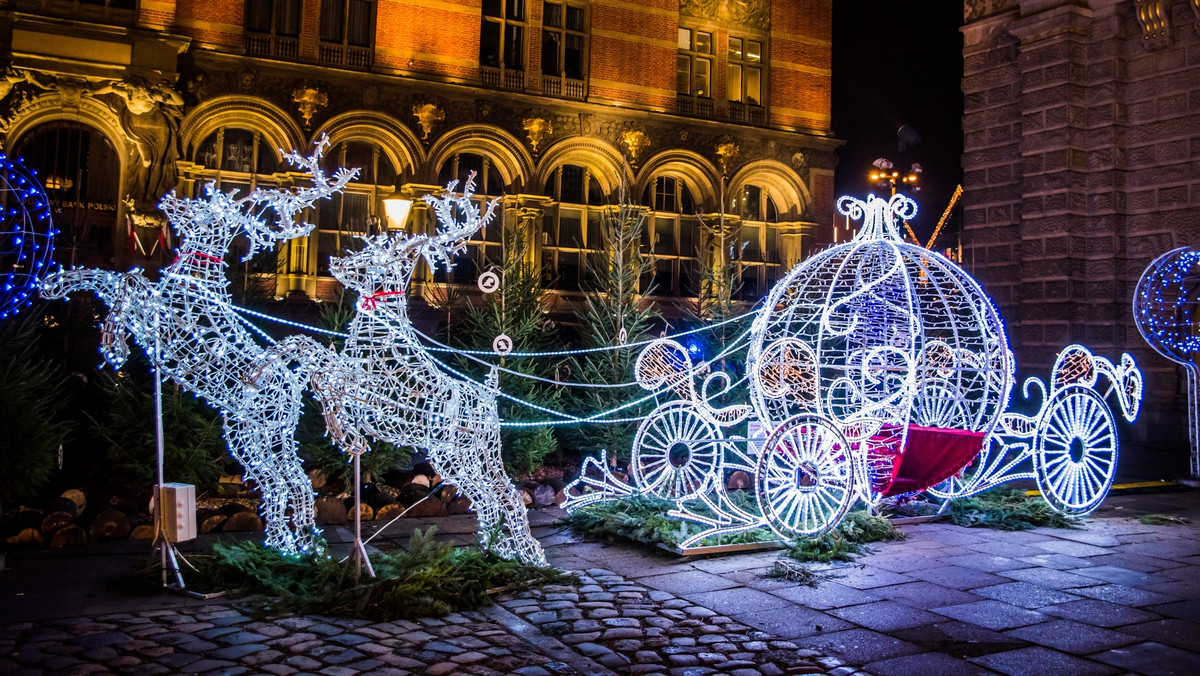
[630,401,724,499]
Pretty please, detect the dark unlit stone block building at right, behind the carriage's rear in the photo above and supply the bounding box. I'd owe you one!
[962,0,1200,473]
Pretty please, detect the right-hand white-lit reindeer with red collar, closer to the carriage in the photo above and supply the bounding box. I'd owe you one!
[276,173,546,570]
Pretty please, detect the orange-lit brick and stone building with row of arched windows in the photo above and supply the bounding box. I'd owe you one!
[0,0,838,316]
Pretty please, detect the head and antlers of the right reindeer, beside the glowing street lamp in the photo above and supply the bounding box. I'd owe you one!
[329,172,499,295]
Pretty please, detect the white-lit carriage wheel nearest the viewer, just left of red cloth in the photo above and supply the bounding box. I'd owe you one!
[755,413,854,538]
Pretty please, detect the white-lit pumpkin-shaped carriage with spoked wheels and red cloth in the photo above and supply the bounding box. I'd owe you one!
[574,195,1141,548]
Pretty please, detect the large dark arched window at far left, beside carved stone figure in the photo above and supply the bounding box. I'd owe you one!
[16,121,121,267]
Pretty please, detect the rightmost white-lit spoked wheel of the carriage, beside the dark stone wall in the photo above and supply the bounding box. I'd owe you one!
[1033,385,1117,515]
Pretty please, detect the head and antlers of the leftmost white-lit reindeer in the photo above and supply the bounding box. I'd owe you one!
[158,136,358,261]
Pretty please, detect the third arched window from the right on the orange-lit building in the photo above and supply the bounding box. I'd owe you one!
[541,164,605,291]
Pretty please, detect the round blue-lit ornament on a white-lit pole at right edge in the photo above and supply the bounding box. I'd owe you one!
[1133,246,1200,477]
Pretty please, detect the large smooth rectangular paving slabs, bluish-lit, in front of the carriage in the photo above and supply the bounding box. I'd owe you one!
[548,491,1200,676]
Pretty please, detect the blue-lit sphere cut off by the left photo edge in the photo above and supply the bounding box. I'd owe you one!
[0,152,56,319]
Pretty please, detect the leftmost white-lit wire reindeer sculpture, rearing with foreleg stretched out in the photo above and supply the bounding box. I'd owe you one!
[42,139,354,554]
